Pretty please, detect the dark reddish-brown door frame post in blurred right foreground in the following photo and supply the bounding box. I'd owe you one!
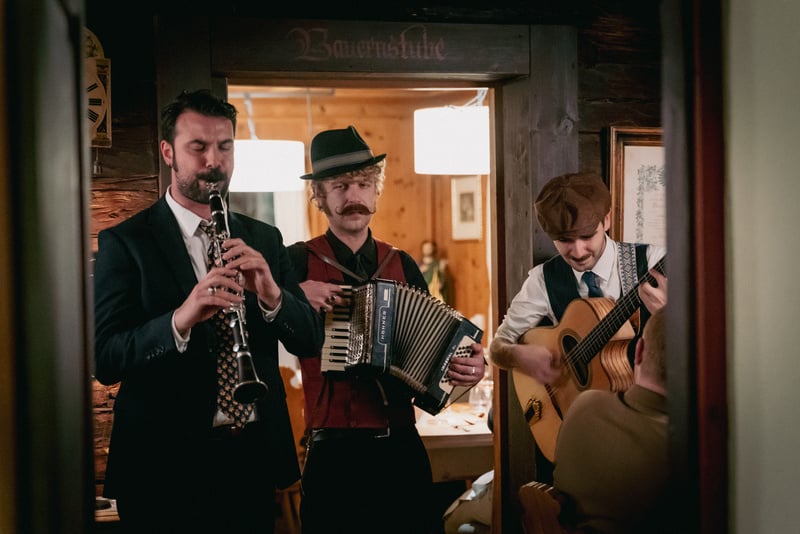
[661,0,729,533]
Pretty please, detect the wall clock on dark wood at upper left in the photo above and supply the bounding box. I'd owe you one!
[84,28,111,148]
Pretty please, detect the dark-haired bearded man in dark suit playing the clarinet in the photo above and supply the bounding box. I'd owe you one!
[94,90,323,533]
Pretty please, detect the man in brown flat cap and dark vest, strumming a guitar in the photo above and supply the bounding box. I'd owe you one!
[490,173,667,483]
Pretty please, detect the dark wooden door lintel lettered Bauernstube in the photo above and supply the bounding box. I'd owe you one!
[211,18,529,80]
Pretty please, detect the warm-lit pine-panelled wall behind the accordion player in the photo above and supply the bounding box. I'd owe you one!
[229,86,491,333]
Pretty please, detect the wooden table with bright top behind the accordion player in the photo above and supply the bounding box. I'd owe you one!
[417,402,494,482]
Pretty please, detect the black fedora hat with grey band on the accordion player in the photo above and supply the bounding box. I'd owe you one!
[300,126,386,180]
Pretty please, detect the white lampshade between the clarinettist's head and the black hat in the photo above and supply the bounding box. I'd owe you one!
[230,139,306,192]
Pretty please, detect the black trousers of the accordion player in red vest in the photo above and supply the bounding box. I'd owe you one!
[300,427,434,534]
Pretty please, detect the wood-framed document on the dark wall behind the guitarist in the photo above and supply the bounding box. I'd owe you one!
[608,126,667,246]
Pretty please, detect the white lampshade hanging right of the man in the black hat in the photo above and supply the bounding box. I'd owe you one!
[414,106,490,175]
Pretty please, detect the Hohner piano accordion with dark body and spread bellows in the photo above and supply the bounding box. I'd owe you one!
[321,279,483,415]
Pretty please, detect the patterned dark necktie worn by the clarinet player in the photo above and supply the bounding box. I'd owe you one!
[200,221,253,428]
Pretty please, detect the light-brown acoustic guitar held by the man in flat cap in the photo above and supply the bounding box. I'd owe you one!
[512,258,665,462]
